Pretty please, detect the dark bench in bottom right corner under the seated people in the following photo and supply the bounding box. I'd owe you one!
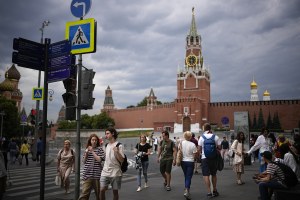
[274,182,300,200]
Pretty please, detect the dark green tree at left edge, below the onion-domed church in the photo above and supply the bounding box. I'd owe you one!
[0,97,23,138]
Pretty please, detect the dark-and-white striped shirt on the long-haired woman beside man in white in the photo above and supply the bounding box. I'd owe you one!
[82,147,105,180]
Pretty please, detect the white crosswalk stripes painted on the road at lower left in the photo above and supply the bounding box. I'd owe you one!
[6,166,136,200]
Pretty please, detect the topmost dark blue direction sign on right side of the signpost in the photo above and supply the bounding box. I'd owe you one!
[49,40,71,58]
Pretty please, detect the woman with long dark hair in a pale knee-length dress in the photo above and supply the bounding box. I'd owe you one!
[231,132,246,185]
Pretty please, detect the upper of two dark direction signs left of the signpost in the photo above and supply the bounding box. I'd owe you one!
[13,38,45,58]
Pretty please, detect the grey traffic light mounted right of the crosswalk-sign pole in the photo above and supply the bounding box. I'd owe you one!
[81,69,96,110]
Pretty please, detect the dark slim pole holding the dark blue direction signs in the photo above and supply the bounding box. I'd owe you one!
[40,38,51,200]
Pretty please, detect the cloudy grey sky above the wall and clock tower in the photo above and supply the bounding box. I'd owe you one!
[0,0,300,121]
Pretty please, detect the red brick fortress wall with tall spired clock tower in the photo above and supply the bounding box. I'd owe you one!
[102,9,300,132]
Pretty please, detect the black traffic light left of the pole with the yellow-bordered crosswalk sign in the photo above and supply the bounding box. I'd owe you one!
[62,56,77,120]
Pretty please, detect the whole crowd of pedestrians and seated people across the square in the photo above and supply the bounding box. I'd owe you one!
[0,124,300,200]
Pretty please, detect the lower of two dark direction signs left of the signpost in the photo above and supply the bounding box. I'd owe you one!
[12,52,45,71]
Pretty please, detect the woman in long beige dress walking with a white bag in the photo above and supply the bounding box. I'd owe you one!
[57,140,75,194]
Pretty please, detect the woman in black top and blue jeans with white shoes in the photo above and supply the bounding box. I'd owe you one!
[135,134,151,192]
